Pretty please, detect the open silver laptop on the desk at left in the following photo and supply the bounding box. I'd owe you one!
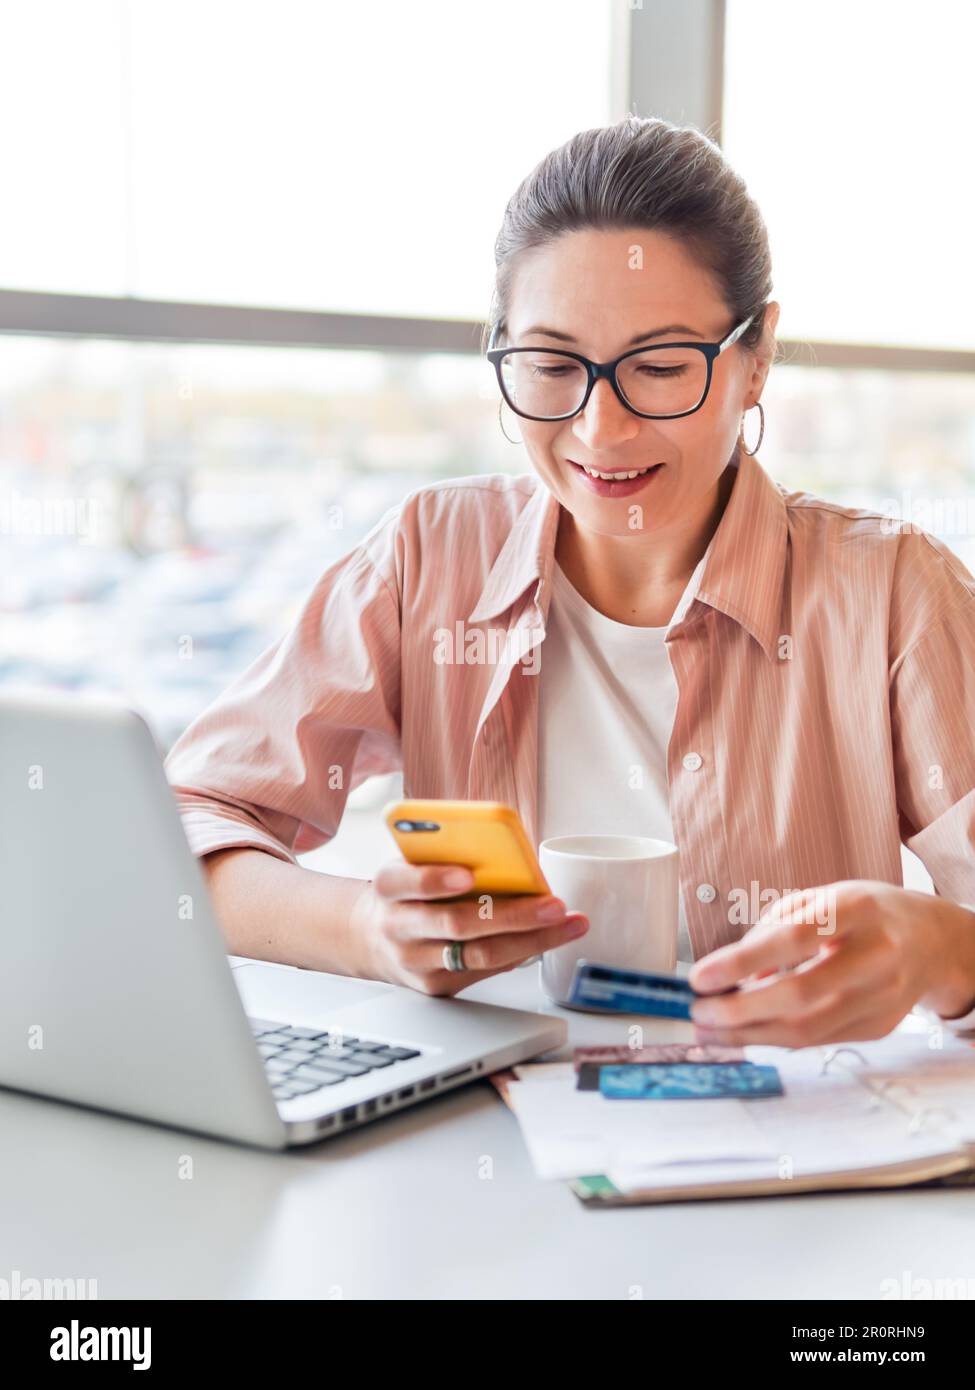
[0,691,566,1148]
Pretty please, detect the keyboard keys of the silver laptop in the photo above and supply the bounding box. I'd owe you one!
[248,1019,420,1101]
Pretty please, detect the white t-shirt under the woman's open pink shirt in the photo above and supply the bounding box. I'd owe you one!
[538,550,708,960]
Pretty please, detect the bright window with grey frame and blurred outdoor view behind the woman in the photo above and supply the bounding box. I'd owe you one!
[0,0,975,889]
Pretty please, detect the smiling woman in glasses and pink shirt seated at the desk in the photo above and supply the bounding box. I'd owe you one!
[167,117,975,1047]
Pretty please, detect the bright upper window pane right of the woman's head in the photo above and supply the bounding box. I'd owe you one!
[722,0,975,350]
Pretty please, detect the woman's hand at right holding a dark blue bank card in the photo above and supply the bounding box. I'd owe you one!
[690,878,975,1047]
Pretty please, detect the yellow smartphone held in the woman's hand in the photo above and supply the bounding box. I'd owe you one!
[382,801,552,898]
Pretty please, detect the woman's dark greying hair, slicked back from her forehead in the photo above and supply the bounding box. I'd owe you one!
[481,115,772,361]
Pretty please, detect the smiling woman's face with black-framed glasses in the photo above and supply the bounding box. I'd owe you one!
[506,228,779,535]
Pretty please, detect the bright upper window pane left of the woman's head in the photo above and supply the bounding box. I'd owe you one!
[0,0,612,318]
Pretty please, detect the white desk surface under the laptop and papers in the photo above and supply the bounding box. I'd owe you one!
[0,969,975,1298]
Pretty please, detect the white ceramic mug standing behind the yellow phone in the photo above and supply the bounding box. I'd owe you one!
[538,835,680,1004]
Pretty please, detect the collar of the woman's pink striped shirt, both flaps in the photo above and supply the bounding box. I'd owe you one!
[467,450,789,659]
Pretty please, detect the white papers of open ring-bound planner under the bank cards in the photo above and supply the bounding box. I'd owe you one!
[498,1031,975,1194]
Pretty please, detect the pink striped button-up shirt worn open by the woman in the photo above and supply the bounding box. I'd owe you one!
[167,453,975,956]
